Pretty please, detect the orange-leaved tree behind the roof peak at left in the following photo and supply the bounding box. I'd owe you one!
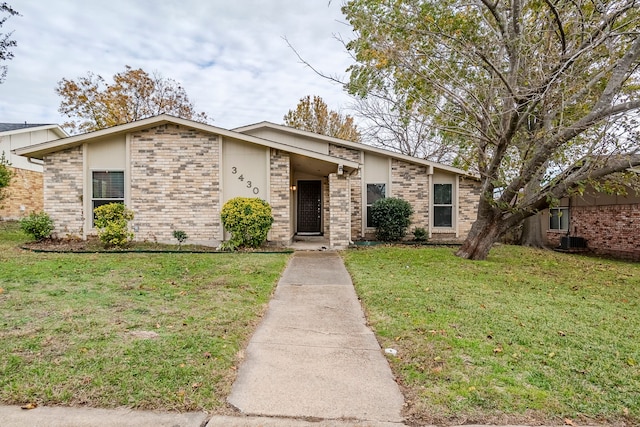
[56,65,209,133]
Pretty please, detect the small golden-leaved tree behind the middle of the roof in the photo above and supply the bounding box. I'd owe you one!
[284,95,360,142]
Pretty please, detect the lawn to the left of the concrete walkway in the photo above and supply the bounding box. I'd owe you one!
[0,222,287,411]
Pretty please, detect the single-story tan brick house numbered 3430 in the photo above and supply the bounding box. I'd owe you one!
[15,115,480,248]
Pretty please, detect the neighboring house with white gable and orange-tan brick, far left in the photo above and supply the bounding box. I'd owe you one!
[0,123,67,219]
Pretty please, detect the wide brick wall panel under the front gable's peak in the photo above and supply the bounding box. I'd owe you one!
[129,125,221,244]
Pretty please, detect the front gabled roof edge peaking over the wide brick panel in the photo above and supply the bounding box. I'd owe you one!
[14,114,360,169]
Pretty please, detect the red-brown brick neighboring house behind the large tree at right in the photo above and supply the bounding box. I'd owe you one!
[540,188,640,261]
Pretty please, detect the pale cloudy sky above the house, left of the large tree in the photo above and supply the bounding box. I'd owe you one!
[0,0,352,129]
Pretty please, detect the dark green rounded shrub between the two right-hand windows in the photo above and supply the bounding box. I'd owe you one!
[371,197,413,242]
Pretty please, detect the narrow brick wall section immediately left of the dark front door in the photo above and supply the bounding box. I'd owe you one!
[269,150,291,245]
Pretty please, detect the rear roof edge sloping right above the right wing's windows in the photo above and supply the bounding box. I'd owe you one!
[233,121,477,178]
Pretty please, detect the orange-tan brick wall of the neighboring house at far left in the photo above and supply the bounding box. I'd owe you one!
[0,167,44,219]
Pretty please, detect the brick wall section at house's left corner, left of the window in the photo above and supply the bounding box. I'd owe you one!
[44,146,84,237]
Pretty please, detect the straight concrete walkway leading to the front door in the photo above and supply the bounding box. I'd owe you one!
[228,251,404,423]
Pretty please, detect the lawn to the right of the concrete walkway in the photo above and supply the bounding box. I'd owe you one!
[344,246,640,425]
